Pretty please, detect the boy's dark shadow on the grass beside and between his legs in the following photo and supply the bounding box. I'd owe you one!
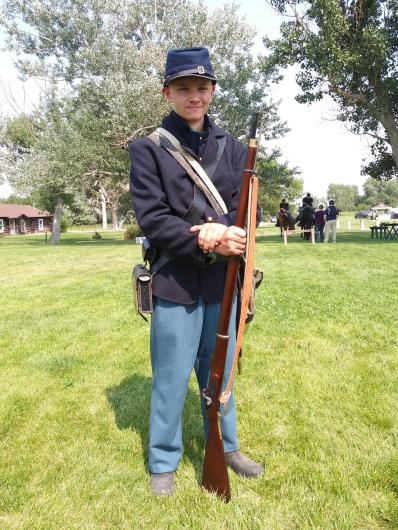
[106,373,204,483]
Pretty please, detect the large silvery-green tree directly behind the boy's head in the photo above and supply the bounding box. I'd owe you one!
[2,0,286,239]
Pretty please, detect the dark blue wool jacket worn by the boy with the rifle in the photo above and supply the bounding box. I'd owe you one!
[129,111,250,304]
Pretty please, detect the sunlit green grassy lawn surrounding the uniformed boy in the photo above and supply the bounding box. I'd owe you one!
[0,228,398,530]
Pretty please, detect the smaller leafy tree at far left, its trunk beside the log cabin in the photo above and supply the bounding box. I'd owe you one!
[1,95,89,243]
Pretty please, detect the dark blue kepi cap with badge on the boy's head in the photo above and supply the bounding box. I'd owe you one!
[163,48,217,86]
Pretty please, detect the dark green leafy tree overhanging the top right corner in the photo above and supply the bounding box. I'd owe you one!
[264,0,398,180]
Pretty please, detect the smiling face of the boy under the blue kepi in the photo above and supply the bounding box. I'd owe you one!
[162,77,216,130]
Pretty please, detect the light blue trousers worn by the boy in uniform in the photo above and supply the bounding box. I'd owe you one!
[149,298,239,473]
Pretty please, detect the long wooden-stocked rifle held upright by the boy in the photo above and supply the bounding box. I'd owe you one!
[202,113,259,502]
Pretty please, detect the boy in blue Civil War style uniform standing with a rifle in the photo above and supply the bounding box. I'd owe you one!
[130,48,263,495]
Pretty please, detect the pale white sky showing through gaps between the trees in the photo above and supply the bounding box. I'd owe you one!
[0,0,369,199]
